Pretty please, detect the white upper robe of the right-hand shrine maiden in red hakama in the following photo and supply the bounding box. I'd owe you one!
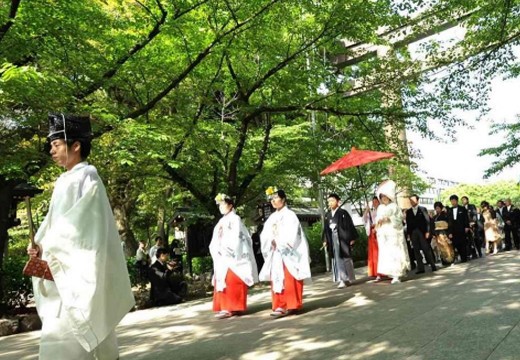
[259,206,311,294]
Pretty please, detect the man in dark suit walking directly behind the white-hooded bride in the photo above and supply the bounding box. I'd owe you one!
[406,195,437,274]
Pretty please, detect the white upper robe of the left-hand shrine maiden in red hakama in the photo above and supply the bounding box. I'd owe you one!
[209,210,258,291]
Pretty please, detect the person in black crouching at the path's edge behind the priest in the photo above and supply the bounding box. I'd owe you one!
[148,248,182,306]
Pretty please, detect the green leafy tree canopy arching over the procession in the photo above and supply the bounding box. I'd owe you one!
[0,0,518,250]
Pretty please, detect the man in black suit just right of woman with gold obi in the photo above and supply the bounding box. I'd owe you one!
[448,195,469,262]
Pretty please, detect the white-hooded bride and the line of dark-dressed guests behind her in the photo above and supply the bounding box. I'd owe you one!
[360,181,520,286]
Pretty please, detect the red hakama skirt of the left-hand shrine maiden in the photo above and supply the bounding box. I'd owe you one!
[213,269,247,312]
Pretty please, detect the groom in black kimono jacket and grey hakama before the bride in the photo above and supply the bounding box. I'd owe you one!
[322,194,359,288]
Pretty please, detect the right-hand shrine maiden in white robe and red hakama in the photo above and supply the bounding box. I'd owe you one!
[260,187,311,318]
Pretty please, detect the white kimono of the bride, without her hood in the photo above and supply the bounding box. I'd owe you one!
[376,202,410,278]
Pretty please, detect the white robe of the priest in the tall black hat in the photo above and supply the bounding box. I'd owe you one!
[33,162,134,360]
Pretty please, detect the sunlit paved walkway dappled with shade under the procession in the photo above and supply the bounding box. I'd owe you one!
[0,251,520,360]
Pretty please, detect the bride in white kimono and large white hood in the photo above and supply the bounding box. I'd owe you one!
[376,180,410,284]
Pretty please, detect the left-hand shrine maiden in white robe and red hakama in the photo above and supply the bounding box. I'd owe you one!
[209,194,258,319]
